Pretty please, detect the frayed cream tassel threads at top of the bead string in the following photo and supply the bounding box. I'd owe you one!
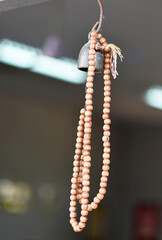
[107,43,124,79]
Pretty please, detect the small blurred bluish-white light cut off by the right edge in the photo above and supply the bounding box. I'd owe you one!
[144,86,162,110]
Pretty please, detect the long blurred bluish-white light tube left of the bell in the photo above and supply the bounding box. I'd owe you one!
[0,39,86,84]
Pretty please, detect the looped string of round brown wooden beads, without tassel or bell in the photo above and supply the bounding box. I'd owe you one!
[69,31,111,232]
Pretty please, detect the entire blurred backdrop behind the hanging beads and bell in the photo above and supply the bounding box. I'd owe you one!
[0,0,162,240]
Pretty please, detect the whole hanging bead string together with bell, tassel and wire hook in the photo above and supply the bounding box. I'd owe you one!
[69,0,123,232]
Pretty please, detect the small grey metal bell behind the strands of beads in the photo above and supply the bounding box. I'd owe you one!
[78,42,105,73]
